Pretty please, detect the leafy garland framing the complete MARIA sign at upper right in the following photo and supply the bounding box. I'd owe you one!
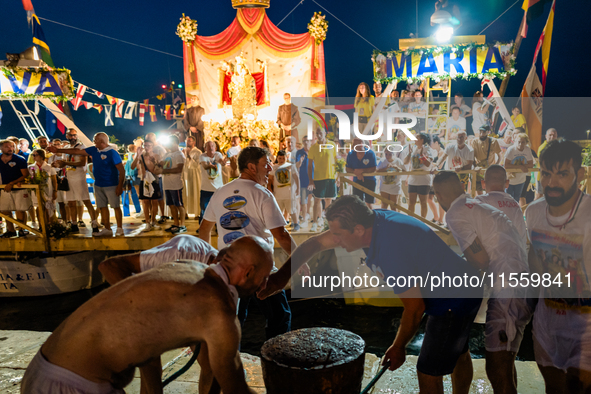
[371,41,517,83]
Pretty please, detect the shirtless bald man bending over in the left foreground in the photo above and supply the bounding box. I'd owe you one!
[21,236,273,394]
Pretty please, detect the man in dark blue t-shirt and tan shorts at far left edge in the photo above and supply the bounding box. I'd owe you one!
[0,140,31,238]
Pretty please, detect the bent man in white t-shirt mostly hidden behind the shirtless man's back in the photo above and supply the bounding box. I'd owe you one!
[98,234,223,285]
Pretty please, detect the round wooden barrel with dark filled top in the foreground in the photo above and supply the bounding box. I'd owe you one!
[261,328,365,394]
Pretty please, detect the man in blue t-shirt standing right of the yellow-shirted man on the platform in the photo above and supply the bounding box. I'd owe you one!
[347,138,378,208]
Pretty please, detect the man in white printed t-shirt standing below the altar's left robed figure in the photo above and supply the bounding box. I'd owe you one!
[199,141,225,223]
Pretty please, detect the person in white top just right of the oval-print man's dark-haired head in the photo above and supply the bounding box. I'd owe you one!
[269,150,300,231]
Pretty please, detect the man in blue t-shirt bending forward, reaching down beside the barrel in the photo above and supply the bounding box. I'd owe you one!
[258,196,482,393]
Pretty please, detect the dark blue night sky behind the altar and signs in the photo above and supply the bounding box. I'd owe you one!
[0,0,591,143]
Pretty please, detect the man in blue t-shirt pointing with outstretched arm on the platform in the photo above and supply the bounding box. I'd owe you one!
[48,133,125,237]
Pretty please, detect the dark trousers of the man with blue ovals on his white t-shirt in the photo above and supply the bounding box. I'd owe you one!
[238,290,291,339]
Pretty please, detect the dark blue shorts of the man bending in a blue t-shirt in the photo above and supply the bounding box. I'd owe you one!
[417,308,478,376]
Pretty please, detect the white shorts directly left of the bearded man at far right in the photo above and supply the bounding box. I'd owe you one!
[484,298,532,353]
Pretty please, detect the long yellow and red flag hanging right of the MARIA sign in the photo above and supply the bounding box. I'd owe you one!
[521,0,556,150]
